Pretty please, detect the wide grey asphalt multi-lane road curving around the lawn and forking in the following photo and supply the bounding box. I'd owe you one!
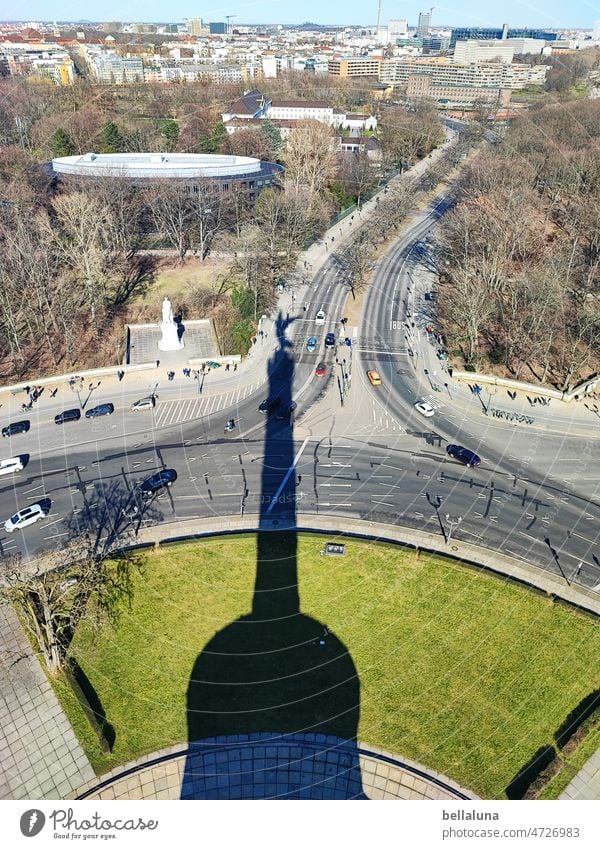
[0,172,600,588]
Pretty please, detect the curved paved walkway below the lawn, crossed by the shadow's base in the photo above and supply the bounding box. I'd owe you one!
[72,733,478,800]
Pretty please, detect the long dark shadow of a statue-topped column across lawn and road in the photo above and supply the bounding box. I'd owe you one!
[181,316,366,799]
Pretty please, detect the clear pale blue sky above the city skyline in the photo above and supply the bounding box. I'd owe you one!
[5,0,600,28]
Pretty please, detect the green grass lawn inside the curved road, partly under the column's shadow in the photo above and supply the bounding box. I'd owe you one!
[57,535,600,798]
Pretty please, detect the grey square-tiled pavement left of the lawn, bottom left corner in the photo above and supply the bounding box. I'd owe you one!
[0,605,94,799]
